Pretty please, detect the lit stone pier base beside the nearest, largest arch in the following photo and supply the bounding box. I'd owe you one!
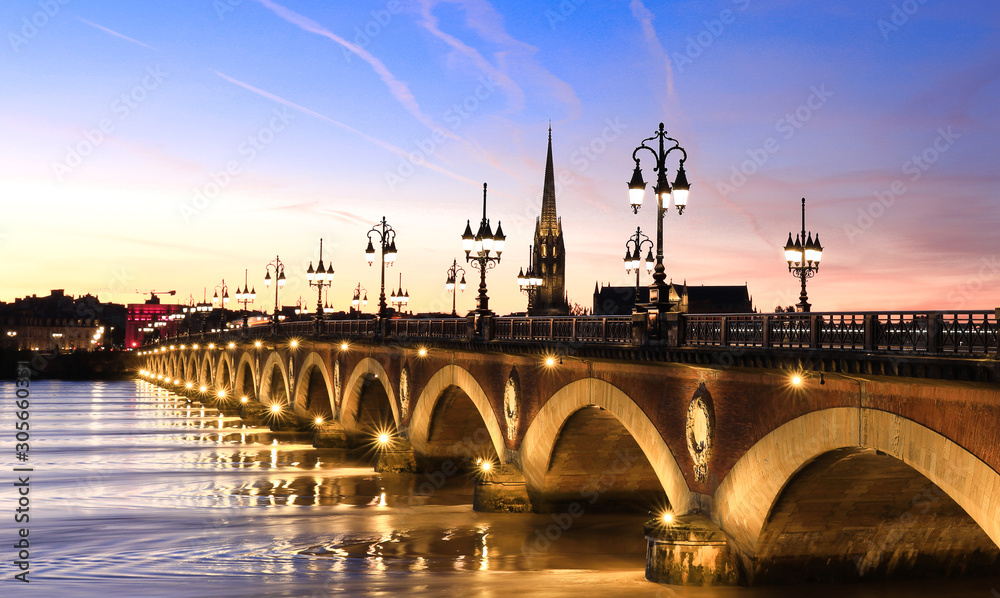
[643,513,739,586]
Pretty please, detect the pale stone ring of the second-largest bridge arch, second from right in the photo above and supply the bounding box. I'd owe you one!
[519,378,696,513]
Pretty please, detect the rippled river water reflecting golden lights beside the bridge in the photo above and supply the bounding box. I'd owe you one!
[7,381,1000,598]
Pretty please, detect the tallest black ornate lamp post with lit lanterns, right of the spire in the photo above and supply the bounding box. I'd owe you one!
[628,123,691,313]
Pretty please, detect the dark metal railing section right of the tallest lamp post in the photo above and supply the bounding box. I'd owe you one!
[684,311,997,354]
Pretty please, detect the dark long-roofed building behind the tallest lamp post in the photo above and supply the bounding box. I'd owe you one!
[593,283,753,315]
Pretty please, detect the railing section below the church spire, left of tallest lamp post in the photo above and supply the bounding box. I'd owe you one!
[493,316,632,344]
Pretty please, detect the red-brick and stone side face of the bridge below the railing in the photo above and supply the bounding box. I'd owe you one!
[143,342,1000,578]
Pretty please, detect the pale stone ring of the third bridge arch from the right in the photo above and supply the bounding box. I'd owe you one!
[409,364,507,468]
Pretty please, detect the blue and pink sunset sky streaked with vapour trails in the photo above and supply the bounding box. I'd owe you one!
[0,0,1000,314]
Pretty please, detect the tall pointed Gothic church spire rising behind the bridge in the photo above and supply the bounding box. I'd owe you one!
[528,127,569,316]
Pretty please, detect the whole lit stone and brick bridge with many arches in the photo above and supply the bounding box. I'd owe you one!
[139,312,1000,584]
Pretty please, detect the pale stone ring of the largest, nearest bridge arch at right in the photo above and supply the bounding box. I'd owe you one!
[713,407,1000,584]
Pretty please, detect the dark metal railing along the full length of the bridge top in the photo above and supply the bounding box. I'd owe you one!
[146,310,1000,357]
